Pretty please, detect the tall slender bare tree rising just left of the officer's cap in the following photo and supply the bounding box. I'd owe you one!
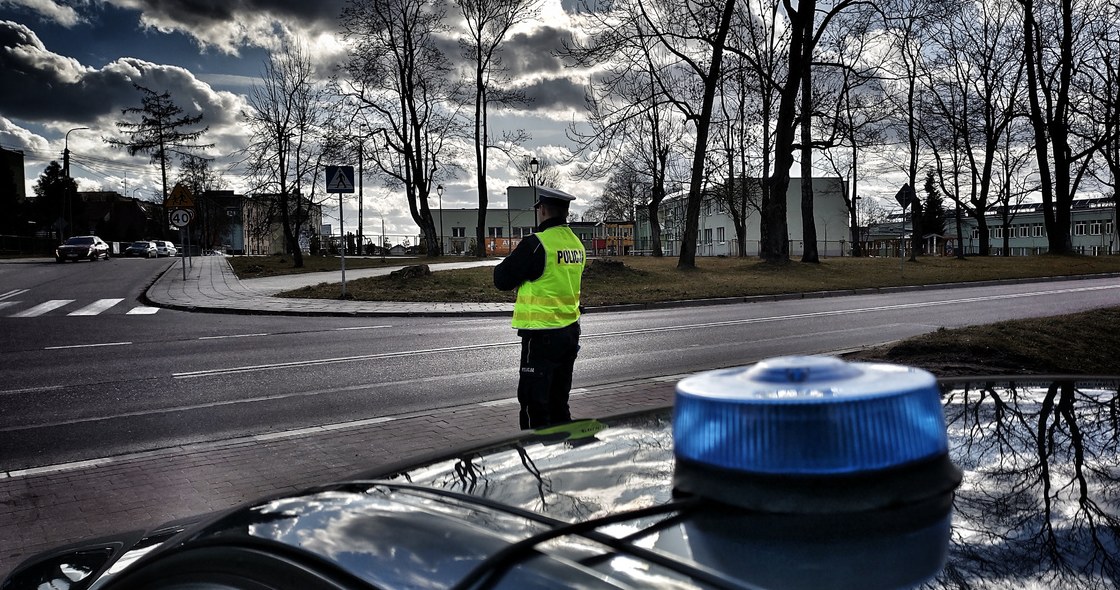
[456,0,538,257]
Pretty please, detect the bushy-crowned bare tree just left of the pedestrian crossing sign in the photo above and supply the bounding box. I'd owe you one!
[242,44,336,268]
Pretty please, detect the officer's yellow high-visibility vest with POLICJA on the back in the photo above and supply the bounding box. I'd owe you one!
[513,225,585,330]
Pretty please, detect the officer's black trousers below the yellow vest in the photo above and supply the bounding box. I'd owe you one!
[517,321,579,430]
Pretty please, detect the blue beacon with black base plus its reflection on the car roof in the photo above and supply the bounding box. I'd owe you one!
[673,356,961,590]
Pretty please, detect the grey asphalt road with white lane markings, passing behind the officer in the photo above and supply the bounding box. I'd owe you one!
[0,259,1120,470]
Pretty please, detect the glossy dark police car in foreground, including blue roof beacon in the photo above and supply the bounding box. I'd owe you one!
[0,357,1120,590]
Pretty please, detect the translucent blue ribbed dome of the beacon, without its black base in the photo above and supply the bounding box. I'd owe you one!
[673,356,949,477]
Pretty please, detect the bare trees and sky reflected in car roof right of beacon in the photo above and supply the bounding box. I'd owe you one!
[933,381,1120,589]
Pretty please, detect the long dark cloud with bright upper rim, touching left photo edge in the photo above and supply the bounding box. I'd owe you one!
[0,21,238,124]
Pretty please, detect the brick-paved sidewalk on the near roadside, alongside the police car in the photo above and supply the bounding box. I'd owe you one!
[0,377,679,579]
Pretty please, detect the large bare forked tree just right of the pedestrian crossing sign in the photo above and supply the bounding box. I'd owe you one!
[342,0,463,255]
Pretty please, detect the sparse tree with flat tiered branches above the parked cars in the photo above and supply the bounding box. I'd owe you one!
[105,84,214,205]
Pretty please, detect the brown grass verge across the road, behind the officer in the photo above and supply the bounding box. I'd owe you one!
[252,255,1120,307]
